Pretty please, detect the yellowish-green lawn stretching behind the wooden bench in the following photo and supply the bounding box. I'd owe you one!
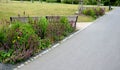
[0,1,109,22]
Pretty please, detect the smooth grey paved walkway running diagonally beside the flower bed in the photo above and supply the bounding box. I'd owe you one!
[19,8,120,70]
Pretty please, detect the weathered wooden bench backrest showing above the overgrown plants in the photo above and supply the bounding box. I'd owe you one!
[10,15,78,28]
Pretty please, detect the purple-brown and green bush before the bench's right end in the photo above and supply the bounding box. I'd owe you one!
[47,17,74,43]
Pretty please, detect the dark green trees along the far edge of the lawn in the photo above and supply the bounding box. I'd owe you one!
[7,0,120,6]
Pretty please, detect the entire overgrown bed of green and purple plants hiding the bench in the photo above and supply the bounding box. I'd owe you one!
[0,17,74,64]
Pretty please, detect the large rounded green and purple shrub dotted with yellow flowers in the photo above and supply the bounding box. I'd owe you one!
[0,22,40,63]
